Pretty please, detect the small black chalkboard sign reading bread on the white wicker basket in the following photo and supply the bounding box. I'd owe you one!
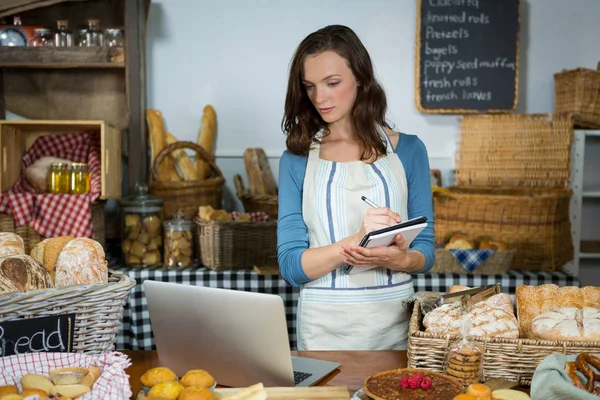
[0,314,75,357]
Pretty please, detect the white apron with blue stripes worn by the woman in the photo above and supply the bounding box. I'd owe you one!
[297,128,414,350]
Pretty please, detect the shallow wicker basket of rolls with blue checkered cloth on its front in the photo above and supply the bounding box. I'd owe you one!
[429,232,516,275]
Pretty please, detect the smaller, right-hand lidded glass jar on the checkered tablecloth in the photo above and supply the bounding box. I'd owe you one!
[164,211,194,268]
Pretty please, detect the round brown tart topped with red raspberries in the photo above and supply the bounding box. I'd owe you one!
[364,368,464,400]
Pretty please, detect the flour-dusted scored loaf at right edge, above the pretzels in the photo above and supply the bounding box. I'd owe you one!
[531,307,600,341]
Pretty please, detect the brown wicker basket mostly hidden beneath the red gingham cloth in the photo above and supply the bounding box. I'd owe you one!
[0,201,106,254]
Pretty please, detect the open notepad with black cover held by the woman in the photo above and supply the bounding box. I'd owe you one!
[342,217,427,274]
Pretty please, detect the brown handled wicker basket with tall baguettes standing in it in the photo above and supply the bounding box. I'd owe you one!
[146,106,225,220]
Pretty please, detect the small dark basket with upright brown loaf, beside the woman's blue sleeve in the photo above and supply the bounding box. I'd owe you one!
[233,148,279,220]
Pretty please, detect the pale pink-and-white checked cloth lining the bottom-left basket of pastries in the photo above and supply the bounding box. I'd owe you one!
[0,351,132,400]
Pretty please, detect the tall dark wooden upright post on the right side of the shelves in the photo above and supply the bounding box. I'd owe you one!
[125,0,148,193]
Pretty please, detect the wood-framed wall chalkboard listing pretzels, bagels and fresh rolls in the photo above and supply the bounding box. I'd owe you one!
[415,0,519,114]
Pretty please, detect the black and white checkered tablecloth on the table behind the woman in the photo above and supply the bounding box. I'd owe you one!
[111,265,579,350]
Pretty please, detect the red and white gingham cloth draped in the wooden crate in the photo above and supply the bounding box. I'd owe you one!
[0,132,102,238]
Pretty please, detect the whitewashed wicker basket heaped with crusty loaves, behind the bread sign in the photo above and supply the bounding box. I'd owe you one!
[0,232,136,353]
